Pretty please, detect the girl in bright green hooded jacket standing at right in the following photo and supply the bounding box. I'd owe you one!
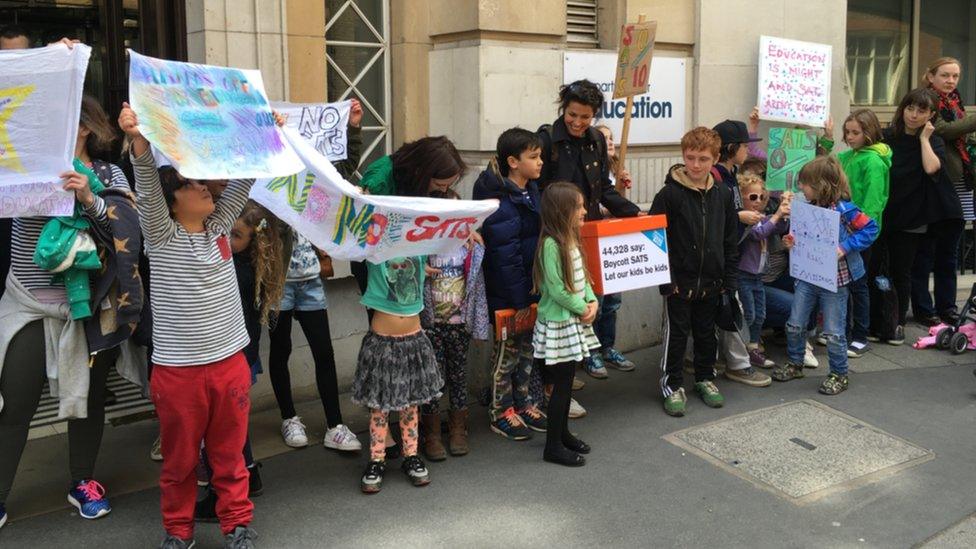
[837,109,891,358]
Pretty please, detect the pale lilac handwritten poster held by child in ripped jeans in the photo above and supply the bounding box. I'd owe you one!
[790,200,840,292]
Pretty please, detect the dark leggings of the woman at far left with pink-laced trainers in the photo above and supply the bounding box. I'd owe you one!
[0,320,119,505]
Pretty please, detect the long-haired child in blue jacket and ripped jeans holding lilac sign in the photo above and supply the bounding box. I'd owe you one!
[773,156,878,395]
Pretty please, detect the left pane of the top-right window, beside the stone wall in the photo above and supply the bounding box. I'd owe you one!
[847,0,911,105]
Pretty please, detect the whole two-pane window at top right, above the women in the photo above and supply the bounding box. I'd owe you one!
[847,0,976,107]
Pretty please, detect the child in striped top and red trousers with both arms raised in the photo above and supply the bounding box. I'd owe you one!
[119,103,283,547]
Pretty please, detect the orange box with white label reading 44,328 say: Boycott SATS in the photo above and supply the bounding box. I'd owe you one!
[582,215,671,295]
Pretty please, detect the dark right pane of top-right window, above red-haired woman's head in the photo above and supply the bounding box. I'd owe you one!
[917,0,976,105]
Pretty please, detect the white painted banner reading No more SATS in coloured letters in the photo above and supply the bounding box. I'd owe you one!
[251,128,498,263]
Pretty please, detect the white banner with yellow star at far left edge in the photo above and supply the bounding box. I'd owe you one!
[0,44,91,217]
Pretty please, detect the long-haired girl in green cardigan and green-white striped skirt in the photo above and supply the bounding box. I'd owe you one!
[532,183,600,467]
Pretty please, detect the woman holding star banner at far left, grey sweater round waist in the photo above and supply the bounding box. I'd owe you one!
[0,97,129,524]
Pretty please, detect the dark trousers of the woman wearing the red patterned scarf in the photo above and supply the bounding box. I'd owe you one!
[912,219,966,318]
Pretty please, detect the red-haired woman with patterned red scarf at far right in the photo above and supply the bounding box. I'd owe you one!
[912,57,976,324]
